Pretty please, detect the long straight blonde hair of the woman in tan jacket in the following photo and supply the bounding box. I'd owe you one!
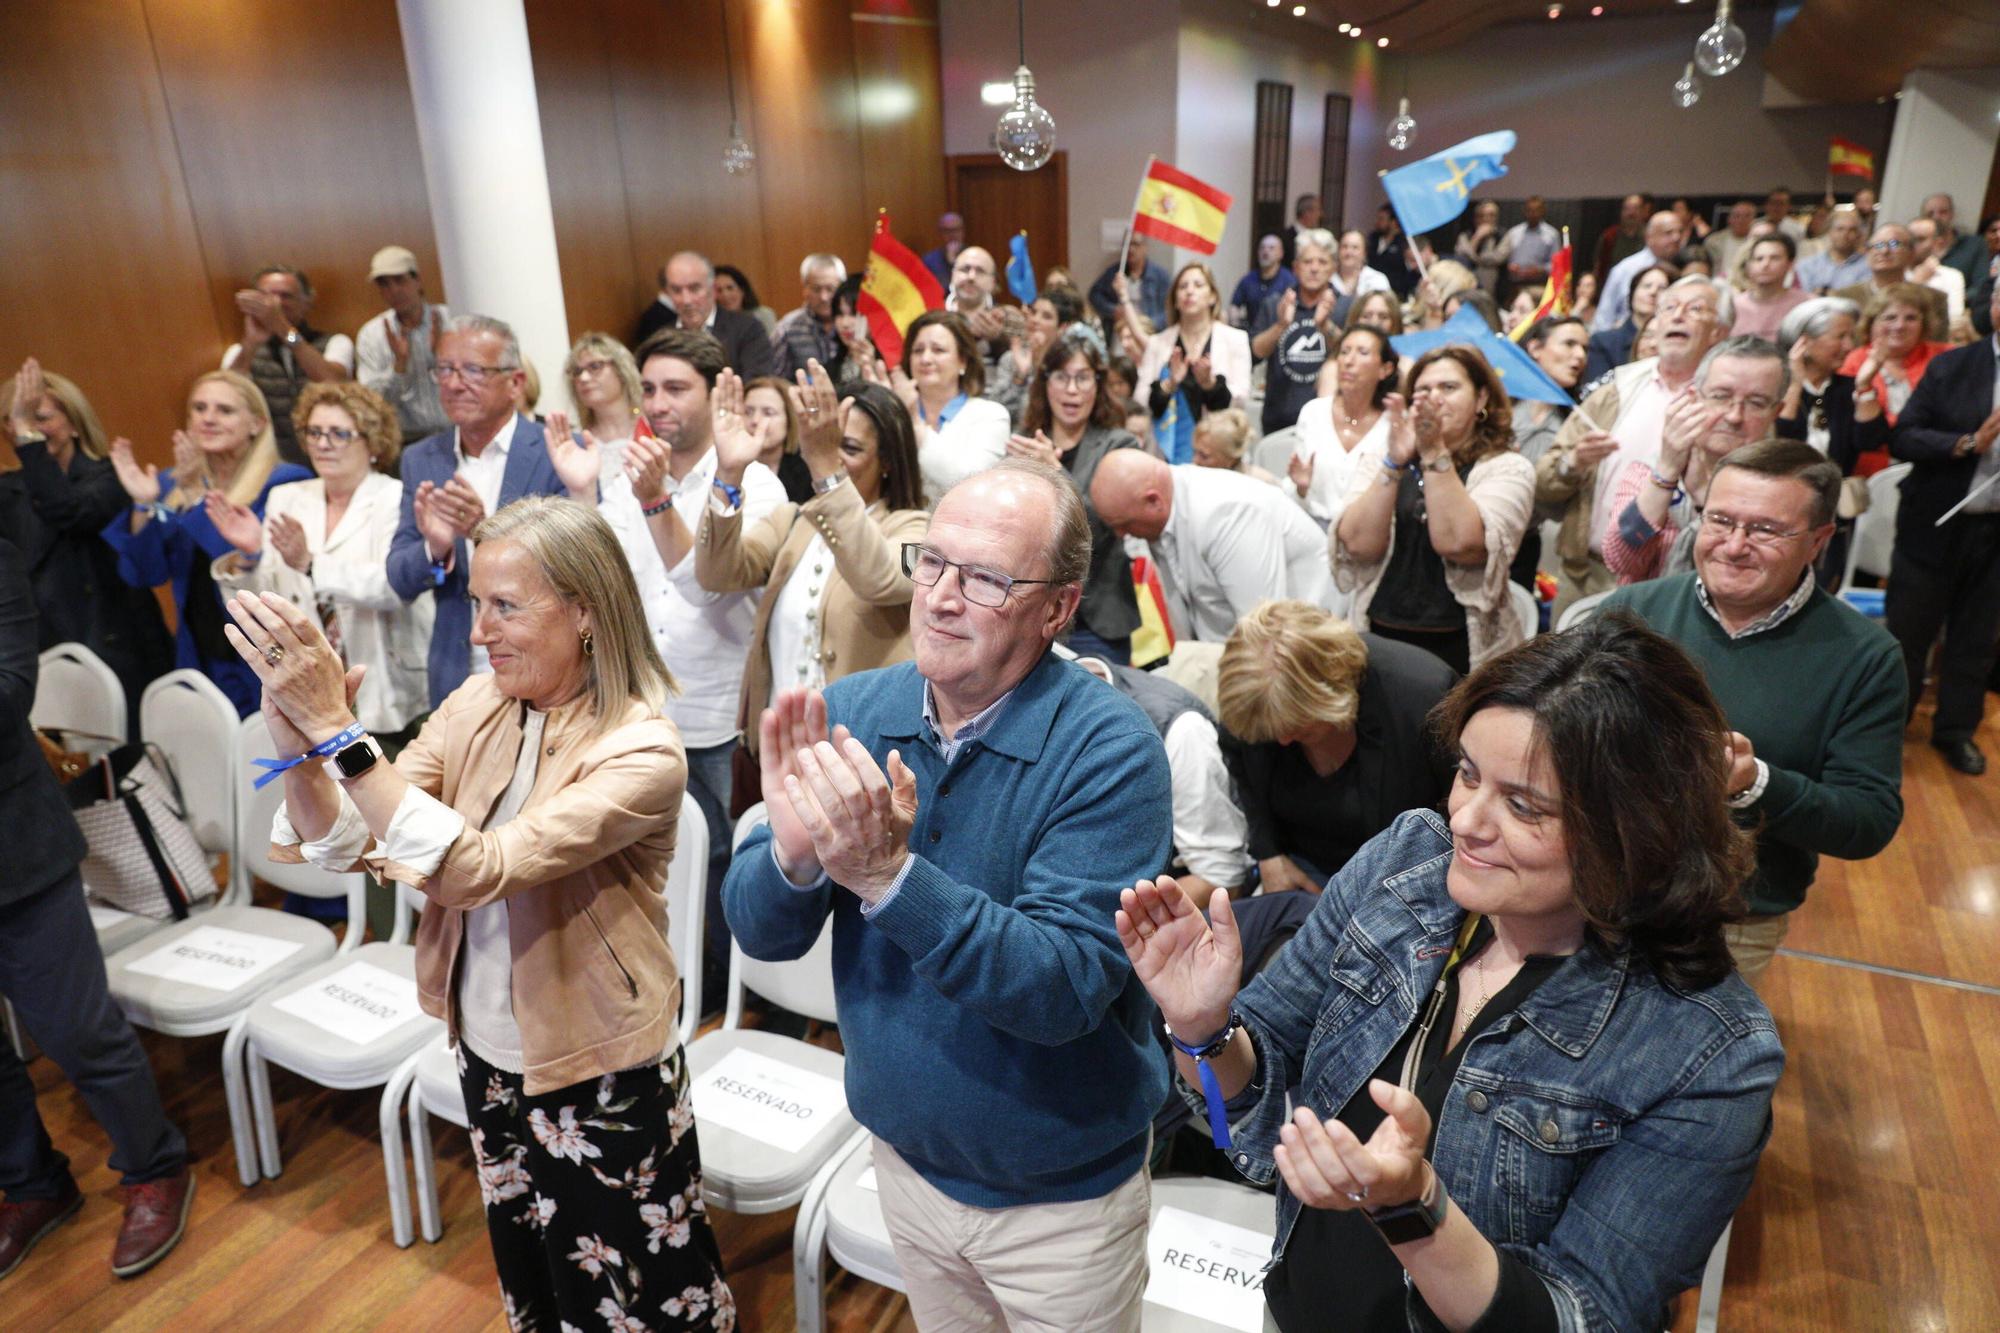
[472,494,676,731]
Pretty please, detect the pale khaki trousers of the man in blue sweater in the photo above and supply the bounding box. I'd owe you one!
[874,1139,1152,1333]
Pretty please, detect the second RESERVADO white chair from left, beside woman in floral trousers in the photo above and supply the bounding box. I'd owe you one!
[222,885,444,1245]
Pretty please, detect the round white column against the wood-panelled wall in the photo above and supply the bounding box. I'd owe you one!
[396,0,570,410]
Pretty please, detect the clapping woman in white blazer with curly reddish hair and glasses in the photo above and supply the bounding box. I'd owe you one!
[212,380,434,732]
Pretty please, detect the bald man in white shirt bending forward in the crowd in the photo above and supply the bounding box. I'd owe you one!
[1090,448,1334,642]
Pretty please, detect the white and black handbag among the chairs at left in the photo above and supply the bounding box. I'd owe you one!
[62,745,216,921]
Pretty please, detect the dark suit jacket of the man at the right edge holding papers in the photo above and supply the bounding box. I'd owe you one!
[1888,338,1994,560]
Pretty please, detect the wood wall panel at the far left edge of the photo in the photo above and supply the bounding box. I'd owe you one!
[0,0,222,462]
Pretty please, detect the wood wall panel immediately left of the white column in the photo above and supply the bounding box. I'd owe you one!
[146,0,442,356]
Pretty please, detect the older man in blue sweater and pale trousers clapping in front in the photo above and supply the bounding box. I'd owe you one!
[722,458,1172,1331]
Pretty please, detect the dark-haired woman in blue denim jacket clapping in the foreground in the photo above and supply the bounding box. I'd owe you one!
[1118,616,1784,1331]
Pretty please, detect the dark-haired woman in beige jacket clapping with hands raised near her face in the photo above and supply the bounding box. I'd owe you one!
[694,362,930,753]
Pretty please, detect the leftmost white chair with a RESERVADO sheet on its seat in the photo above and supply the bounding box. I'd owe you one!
[104,700,368,1153]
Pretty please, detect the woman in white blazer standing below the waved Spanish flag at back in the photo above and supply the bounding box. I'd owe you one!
[1138,264,1250,462]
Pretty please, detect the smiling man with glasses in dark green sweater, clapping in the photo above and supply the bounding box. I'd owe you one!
[1604,440,1908,985]
